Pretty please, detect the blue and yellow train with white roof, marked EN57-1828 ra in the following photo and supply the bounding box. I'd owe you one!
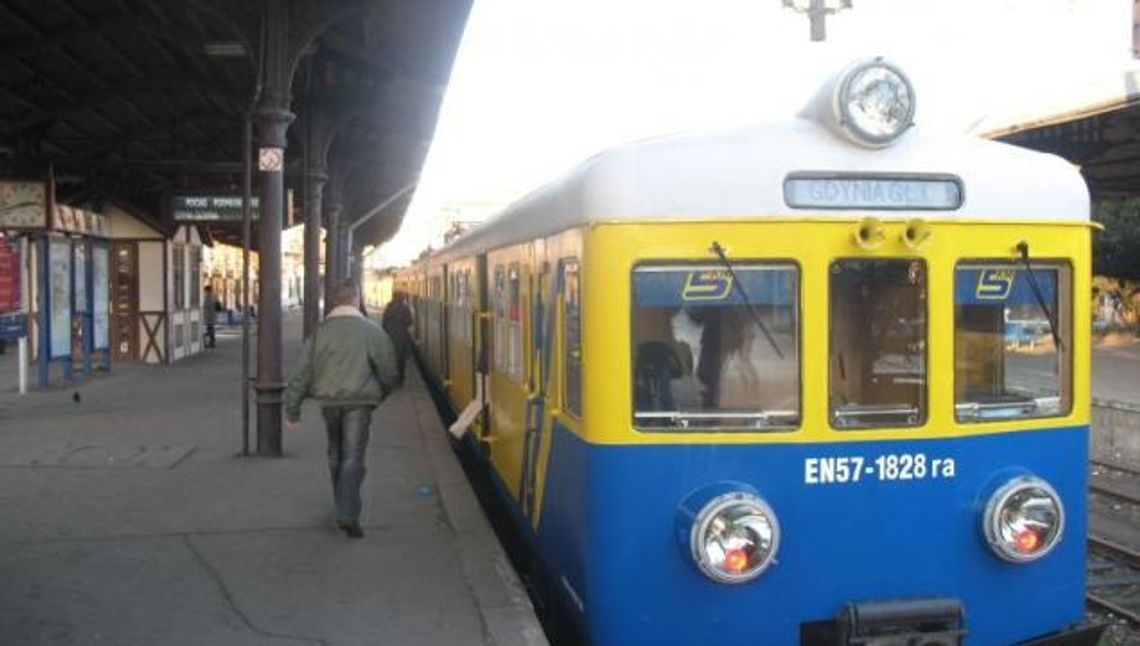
[397,59,1097,645]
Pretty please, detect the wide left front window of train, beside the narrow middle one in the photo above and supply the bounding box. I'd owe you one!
[633,262,800,431]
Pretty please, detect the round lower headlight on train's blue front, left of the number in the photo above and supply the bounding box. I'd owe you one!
[690,491,780,583]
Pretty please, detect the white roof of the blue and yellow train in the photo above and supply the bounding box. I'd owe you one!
[426,117,1090,265]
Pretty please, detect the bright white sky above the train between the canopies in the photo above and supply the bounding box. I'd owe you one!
[372,0,1137,267]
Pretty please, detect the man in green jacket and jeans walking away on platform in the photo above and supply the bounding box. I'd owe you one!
[285,283,397,538]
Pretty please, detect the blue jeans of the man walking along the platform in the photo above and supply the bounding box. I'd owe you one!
[320,407,372,522]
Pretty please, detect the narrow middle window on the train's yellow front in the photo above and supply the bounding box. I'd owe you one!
[829,259,927,430]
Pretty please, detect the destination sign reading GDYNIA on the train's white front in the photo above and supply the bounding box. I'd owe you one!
[784,174,962,211]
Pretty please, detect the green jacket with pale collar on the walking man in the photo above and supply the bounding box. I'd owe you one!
[285,308,399,422]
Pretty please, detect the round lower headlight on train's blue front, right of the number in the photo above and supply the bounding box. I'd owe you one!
[984,476,1065,563]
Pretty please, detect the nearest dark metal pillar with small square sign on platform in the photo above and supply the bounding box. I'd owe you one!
[254,0,293,456]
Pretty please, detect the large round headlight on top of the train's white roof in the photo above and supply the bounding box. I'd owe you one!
[833,58,914,148]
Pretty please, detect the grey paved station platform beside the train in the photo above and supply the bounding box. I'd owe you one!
[0,314,546,646]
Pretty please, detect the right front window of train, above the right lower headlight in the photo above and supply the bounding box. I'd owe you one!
[954,262,1072,422]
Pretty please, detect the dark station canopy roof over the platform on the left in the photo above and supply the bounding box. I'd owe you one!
[0,0,471,245]
